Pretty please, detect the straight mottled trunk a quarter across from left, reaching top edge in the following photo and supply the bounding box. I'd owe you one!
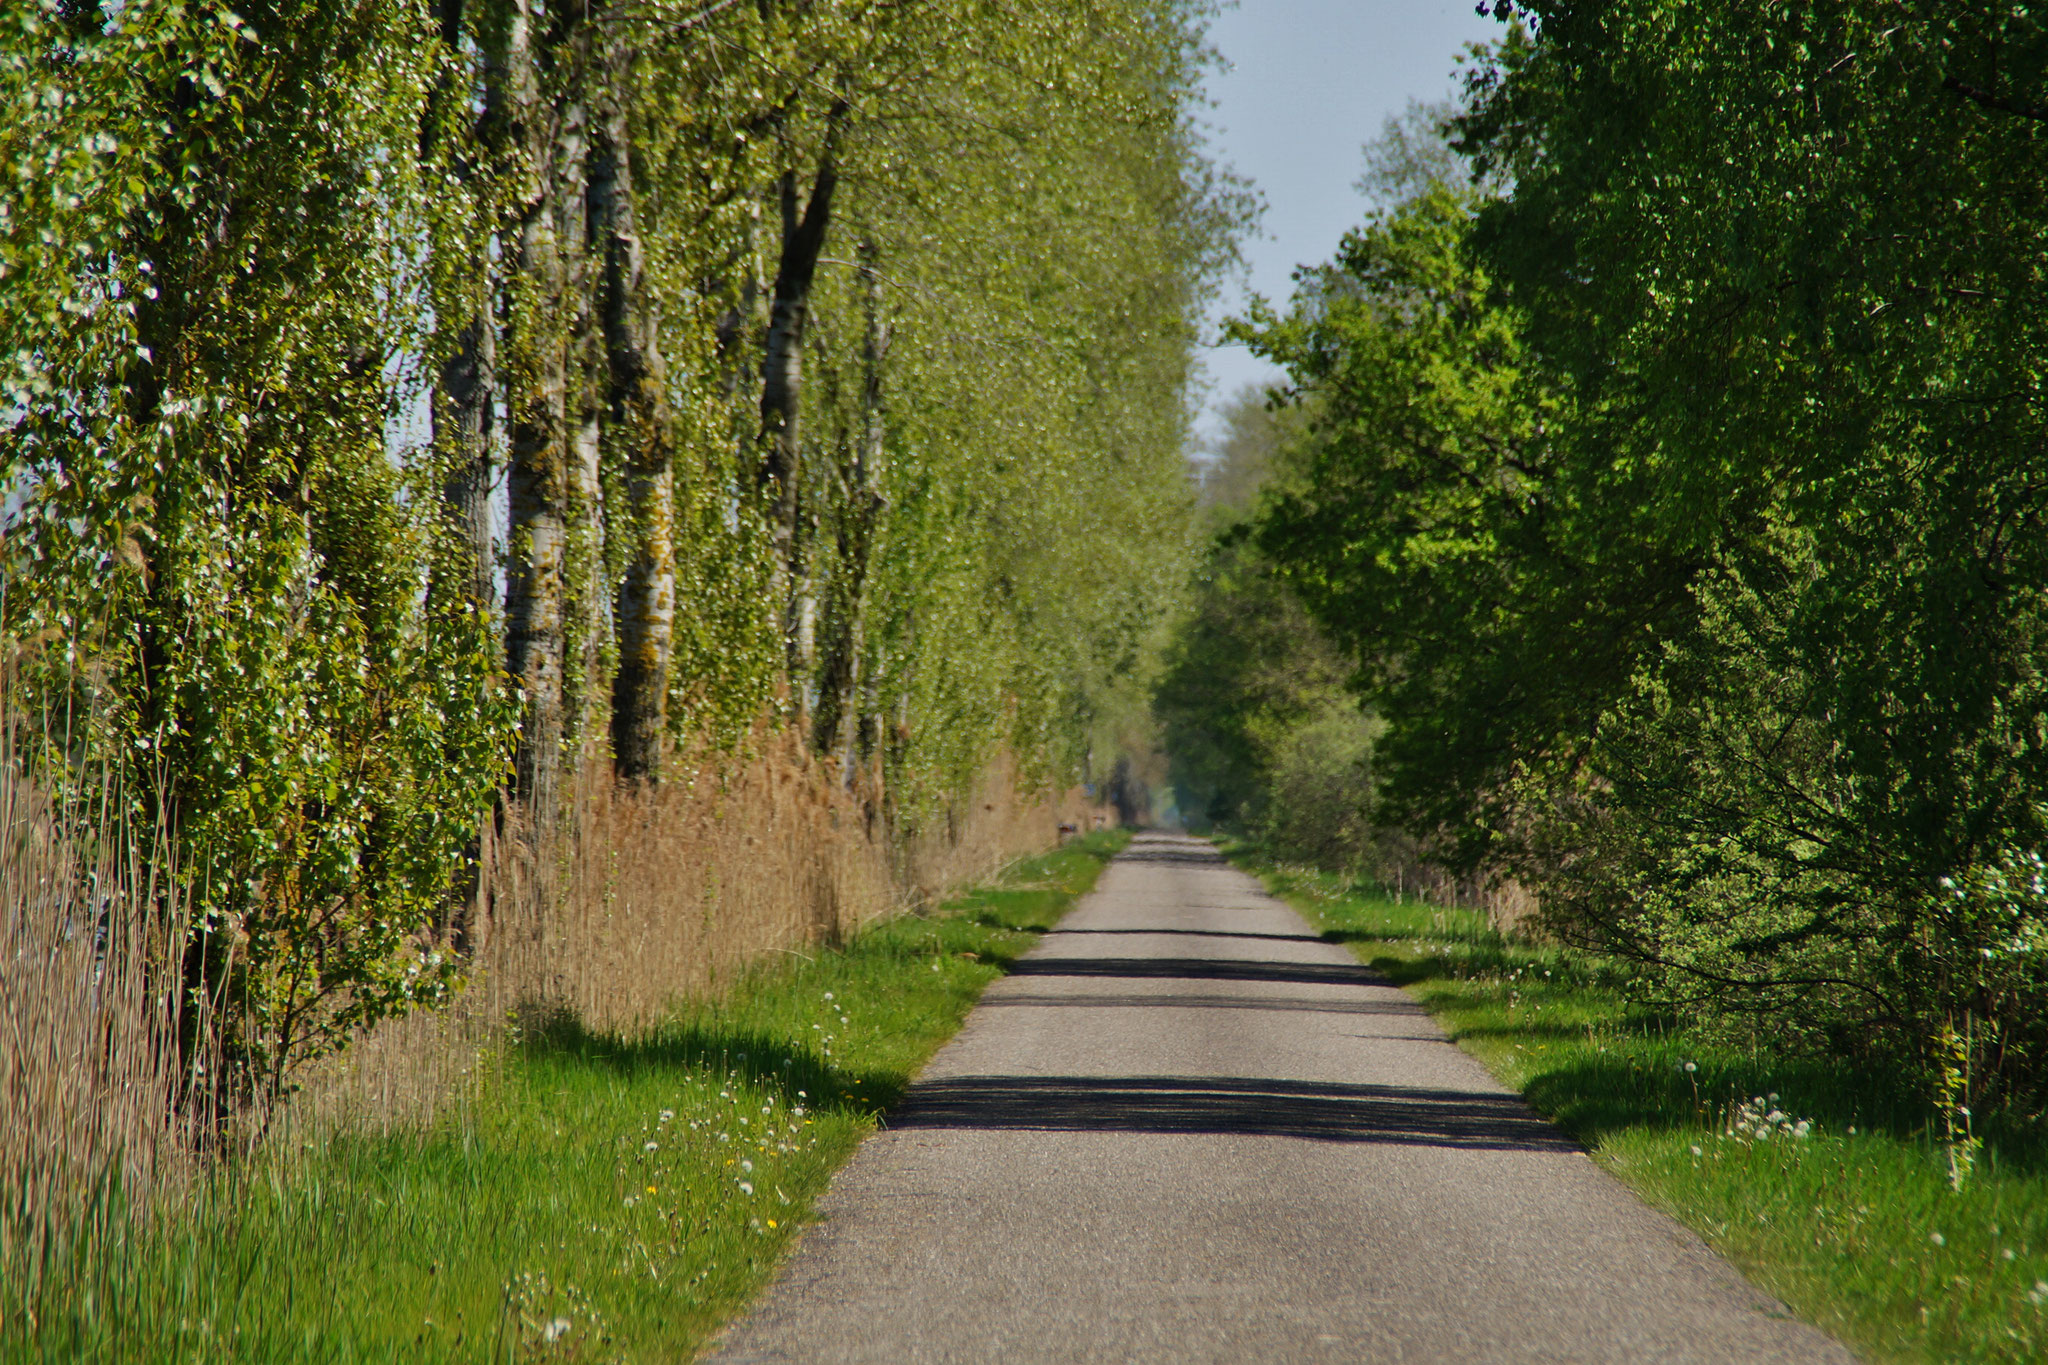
[504,0,569,831]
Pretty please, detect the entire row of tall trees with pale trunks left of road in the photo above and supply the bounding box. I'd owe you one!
[0,0,1239,1076]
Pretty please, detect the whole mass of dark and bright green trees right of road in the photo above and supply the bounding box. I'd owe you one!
[1243,0,2048,1095]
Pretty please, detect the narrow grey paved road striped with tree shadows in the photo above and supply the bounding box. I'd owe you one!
[713,835,1849,1365]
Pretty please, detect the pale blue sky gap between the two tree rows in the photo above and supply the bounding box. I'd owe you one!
[1198,0,1499,434]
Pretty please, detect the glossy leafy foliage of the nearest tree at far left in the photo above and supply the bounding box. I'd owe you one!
[0,0,510,1087]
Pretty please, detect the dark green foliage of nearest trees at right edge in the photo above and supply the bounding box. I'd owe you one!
[1466,4,2048,1083]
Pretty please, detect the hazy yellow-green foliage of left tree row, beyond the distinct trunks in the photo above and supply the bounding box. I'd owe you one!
[770,4,1239,810]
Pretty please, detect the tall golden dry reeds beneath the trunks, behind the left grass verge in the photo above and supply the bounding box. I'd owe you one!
[291,726,1090,1132]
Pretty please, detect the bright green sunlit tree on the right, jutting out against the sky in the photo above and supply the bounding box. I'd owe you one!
[1237,184,1564,863]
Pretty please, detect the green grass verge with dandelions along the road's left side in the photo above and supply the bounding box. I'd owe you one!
[0,835,1122,1365]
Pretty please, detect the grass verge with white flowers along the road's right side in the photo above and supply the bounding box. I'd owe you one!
[1235,849,2048,1361]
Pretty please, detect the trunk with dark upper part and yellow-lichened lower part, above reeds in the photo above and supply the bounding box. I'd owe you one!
[590,90,676,782]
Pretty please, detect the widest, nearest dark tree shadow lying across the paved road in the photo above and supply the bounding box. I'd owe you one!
[889,1076,1577,1152]
